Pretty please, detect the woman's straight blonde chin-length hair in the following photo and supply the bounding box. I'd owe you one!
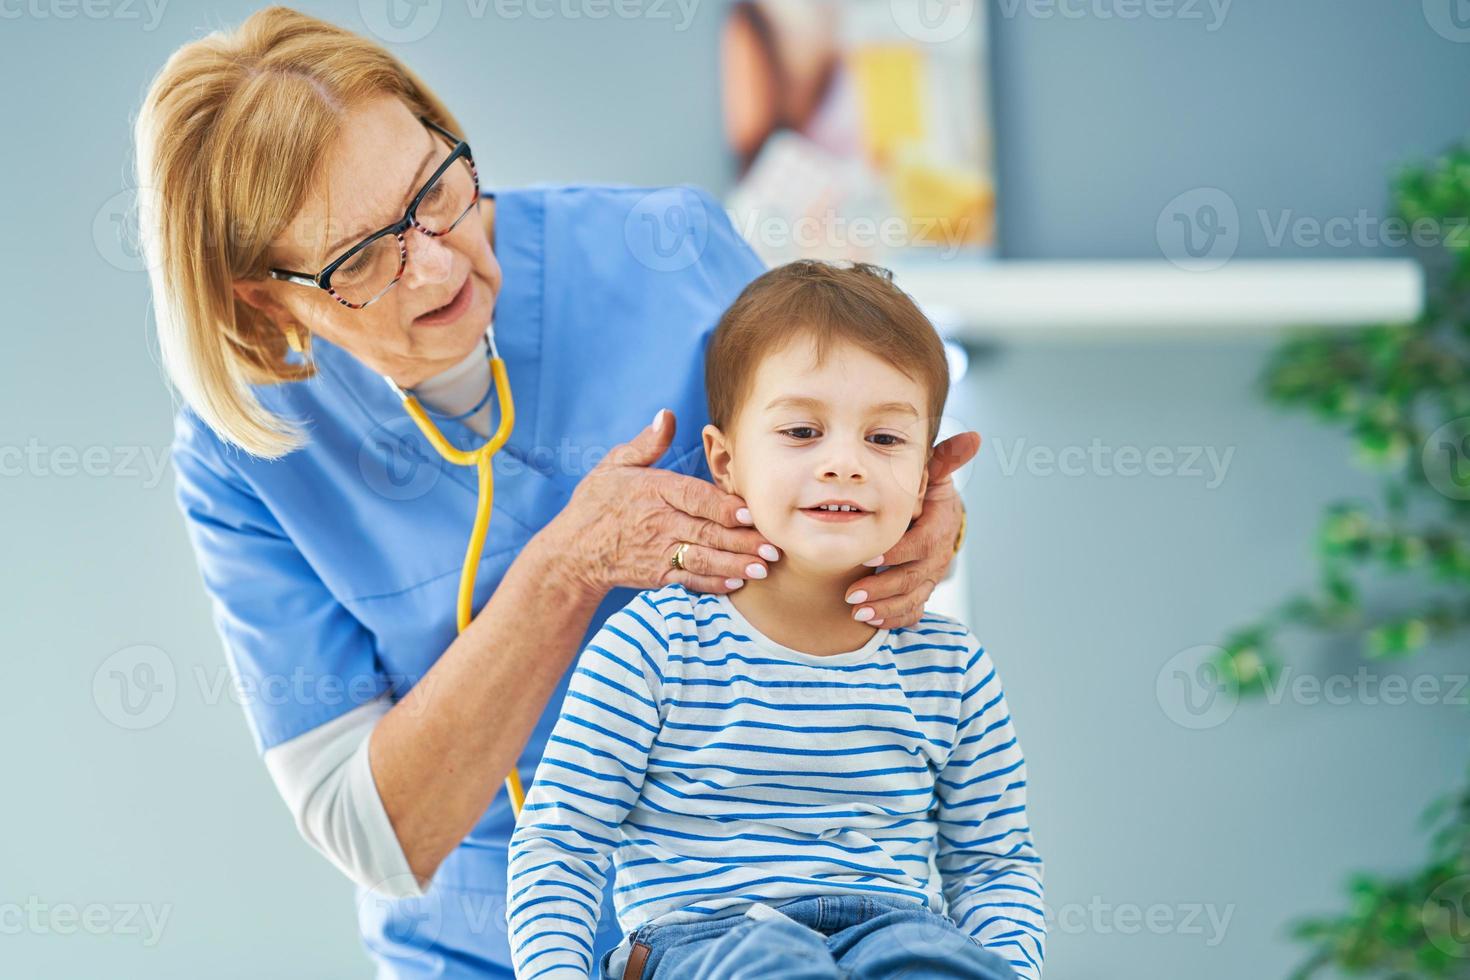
[134,6,460,458]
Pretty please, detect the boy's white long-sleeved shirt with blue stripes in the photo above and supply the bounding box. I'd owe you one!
[507,585,1045,980]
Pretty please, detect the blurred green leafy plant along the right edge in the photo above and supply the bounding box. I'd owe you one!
[1217,132,1470,980]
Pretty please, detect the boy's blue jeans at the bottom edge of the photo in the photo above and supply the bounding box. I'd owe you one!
[600,895,1016,980]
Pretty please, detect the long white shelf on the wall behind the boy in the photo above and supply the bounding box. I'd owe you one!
[894,259,1424,341]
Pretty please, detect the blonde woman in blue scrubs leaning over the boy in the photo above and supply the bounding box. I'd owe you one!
[137,7,979,977]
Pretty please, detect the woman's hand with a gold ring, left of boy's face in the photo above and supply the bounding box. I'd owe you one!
[547,408,781,598]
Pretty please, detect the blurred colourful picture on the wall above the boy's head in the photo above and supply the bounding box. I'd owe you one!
[720,0,995,264]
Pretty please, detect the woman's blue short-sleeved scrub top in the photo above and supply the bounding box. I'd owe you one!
[173,185,763,977]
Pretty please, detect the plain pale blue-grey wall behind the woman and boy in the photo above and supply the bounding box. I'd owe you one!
[0,0,1470,980]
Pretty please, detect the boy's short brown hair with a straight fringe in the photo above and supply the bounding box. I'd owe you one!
[704,259,950,451]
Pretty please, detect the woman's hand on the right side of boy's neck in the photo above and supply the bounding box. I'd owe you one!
[847,432,980,629]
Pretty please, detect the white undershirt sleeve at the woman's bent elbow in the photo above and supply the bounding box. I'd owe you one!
[265,695,426,898]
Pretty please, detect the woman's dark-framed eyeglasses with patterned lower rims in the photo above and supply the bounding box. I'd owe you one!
[269,116,479,310]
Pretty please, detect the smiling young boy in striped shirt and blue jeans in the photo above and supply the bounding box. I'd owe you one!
[507,262,1045,980]
